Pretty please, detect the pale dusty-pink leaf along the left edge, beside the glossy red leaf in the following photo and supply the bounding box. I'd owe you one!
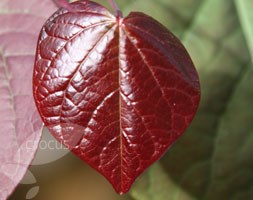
[0,0,56,200]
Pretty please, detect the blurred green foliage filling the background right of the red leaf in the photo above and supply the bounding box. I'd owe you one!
[98,0,253,200]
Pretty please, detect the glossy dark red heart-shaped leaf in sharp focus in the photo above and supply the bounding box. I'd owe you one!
[33,1,200,193]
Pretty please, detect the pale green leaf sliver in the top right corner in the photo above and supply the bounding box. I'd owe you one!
[235,0,253,62]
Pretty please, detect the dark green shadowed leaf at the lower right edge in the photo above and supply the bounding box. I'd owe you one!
[206,66,253,200]
